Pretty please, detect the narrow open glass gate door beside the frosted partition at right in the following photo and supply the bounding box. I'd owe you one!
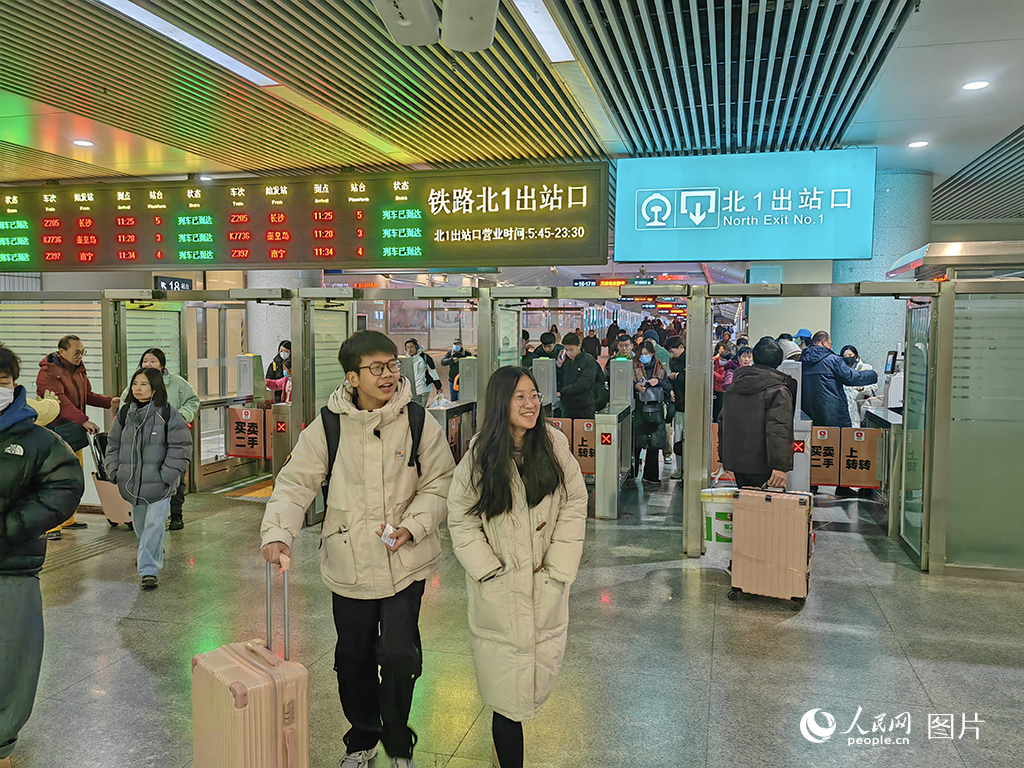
[900,304,932,565]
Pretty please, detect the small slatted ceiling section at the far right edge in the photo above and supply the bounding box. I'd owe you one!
[932,121,1024,221]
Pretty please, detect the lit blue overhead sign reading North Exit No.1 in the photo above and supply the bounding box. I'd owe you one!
[614,148,876,262]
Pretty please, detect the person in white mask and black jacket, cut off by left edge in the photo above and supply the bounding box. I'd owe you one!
[0,344,85,765]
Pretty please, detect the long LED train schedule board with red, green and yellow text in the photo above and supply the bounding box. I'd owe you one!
[0,163,608,271]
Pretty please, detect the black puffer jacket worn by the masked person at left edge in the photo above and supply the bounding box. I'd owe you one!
[0,385,85,573]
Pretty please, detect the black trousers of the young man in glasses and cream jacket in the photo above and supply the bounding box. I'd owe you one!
[334,582,425,758]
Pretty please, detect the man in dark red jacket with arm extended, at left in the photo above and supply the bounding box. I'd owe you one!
[36,335,121,539]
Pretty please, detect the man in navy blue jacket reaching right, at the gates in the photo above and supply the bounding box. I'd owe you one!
[800,331,879,427]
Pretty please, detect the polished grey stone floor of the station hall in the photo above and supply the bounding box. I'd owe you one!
[13,481,1024,768]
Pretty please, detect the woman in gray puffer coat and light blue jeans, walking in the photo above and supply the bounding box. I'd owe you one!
[106,368,191,589]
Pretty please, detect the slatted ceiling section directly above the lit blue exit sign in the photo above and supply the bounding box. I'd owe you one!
[549,0,914,157]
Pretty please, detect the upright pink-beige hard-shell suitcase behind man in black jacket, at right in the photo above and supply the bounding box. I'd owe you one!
[729,488,814,601]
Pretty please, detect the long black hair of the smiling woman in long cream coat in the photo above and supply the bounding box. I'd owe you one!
[470,366,564,520]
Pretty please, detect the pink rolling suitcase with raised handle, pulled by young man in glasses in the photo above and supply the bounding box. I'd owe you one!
[193,556,309,768]
